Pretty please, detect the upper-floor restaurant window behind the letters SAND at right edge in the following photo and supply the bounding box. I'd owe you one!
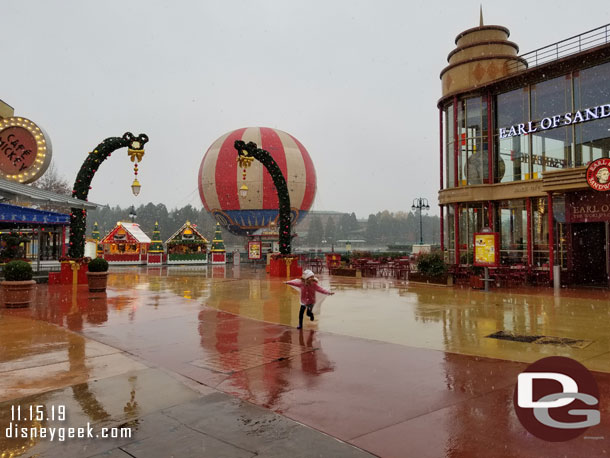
[573,63,610,166]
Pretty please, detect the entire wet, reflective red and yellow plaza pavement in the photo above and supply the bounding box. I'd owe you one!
[0,266,610,458]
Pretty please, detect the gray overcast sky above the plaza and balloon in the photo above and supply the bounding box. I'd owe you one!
[0,0,610,217]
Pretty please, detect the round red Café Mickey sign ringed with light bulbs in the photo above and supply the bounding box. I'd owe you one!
[0,117,52,183]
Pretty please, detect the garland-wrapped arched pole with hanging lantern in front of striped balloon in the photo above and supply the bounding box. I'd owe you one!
[234,140,291,254]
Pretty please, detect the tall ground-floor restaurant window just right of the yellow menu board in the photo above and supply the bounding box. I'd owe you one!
[496,199,527,265]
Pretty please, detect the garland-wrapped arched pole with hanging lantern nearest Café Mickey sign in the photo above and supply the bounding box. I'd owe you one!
[68,132,148,258]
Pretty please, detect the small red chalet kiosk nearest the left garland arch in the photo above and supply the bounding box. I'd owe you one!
[100,221,151,265]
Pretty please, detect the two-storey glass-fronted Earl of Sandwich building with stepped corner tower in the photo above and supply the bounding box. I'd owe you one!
[438,18,610,286]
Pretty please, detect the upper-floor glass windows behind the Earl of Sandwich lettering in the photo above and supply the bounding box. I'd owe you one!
[444,63,610,187]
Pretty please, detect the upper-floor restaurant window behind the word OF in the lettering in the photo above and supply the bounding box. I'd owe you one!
[530,75,574,178]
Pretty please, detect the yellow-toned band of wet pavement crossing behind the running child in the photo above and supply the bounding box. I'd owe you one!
[101,266,610,372]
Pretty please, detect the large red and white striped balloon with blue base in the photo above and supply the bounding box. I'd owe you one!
[199,127,316,235]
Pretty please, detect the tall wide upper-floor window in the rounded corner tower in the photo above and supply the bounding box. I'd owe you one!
[457,97,489,186]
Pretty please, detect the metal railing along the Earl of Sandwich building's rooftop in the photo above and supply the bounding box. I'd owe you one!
[508,24,610,71]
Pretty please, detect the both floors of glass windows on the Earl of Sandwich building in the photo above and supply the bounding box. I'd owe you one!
[441,57,610,276]
